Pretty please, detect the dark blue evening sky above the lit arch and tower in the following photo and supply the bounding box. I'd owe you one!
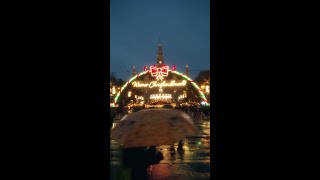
[110,0,210,80]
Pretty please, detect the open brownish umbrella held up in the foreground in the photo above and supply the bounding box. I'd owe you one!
[110,109,197,147]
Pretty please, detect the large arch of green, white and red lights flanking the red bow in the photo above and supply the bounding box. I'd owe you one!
[114,70,208,105]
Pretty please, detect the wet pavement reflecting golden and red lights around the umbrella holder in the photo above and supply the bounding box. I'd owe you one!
[110,120,210,180]
